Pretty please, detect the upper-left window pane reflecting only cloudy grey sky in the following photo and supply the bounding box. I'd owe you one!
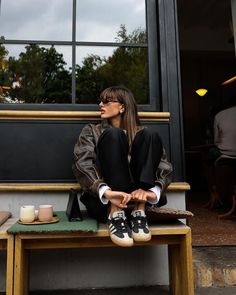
[0,0,72,41]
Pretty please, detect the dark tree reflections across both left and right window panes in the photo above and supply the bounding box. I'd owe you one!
[0,25,148,103]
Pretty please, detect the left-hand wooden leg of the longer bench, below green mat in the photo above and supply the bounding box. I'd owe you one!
[14,236,28,295]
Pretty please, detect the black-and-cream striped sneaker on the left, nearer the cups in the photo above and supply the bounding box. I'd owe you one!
[107,211,134,247]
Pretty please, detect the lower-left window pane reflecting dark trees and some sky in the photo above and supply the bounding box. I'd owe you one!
[0,45,71,103]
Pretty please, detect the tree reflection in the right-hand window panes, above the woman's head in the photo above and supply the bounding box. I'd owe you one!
[76,25,148,103]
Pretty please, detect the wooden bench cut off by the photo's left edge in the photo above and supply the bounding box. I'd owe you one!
[0,218,16,295]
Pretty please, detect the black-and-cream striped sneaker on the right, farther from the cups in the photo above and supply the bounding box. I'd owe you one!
[130,210,152,242]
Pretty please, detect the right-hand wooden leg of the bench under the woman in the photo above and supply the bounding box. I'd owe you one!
[168,230,194,295]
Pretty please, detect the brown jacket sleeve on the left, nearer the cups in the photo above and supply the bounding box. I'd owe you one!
[73,125,103,194]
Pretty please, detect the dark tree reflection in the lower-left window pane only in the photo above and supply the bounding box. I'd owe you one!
[0,45,71,103]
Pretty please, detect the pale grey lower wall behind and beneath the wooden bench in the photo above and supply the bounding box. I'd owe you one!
[0,192,185,292]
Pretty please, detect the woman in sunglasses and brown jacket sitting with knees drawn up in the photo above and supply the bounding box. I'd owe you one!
[73,86,172,247]
